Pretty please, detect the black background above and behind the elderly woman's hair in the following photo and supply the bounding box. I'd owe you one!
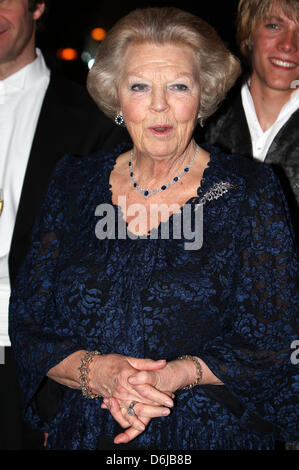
[37,0,238,83]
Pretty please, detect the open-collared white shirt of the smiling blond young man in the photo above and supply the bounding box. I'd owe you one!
[241,83,299,162]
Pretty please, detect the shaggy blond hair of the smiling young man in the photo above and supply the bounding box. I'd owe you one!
[237,0,299,63]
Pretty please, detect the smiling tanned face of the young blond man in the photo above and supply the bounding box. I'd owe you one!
[252,11,299,94]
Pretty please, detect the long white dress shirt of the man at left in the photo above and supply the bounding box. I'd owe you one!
[0,49,50,346]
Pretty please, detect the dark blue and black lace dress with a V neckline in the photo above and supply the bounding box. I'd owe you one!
[10,142,299,450]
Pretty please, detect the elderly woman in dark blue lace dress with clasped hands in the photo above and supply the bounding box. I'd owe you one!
[10,8,299,450]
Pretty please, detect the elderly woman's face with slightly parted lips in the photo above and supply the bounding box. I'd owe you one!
[119,43,200,157]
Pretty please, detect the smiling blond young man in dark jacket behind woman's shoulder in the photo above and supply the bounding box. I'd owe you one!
[204,0,299,243]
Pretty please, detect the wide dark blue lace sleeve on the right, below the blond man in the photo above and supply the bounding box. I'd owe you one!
[200,168,299,440]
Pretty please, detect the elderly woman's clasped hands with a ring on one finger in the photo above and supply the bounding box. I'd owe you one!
[90,354,180,444]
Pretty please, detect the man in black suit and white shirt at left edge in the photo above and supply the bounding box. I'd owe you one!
[0,0,128,450]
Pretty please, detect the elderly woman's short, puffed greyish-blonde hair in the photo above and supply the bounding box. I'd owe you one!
[87,7,241,118]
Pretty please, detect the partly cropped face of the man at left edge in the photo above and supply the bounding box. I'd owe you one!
[0,0,44,65]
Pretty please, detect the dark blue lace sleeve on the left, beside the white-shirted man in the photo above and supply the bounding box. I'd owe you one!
[9,157,80,432]
